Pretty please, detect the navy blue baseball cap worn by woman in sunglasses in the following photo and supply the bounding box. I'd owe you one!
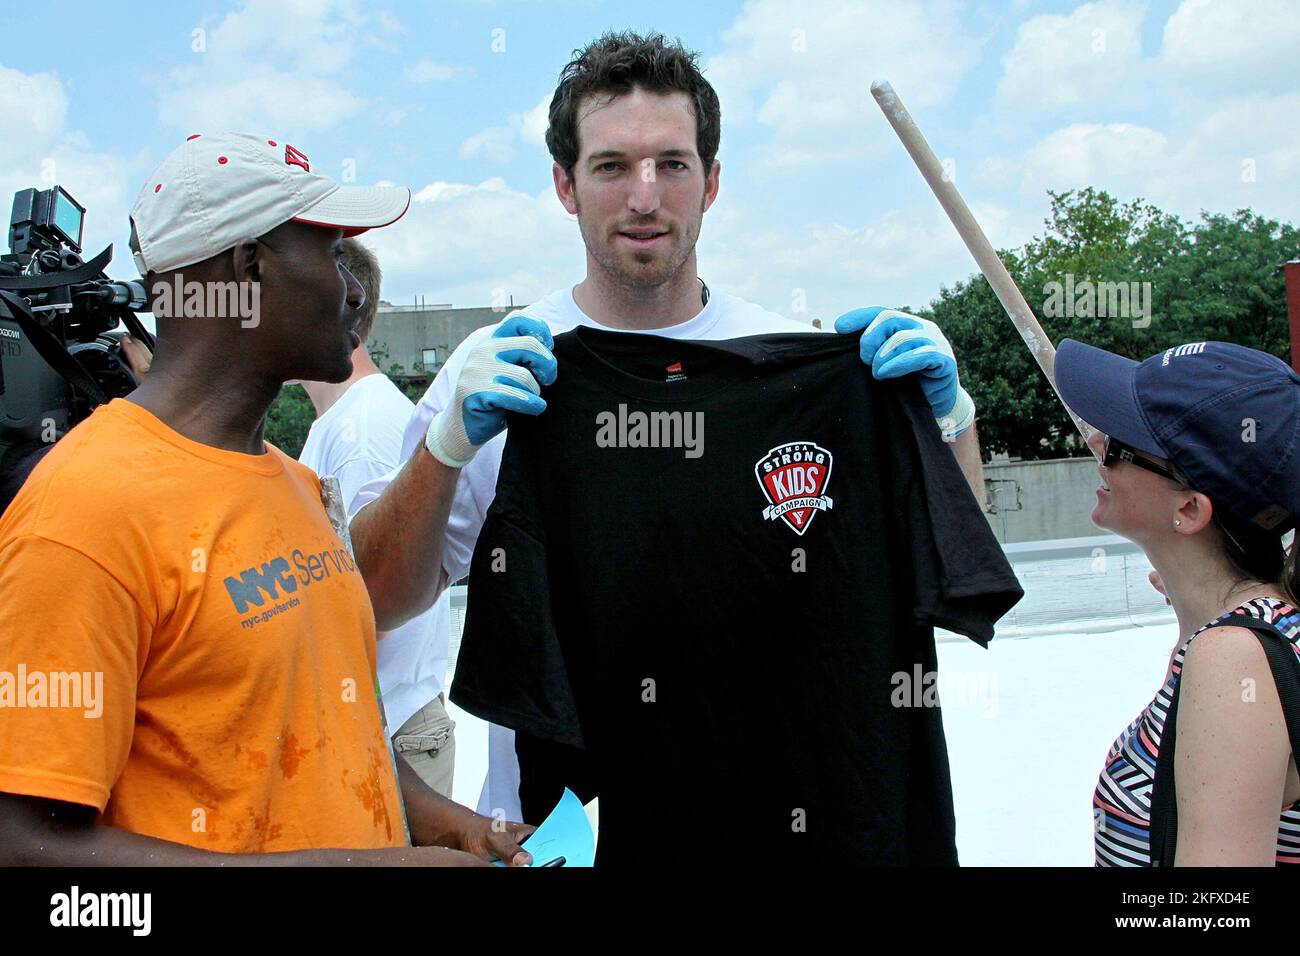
[1056,338,1300,535]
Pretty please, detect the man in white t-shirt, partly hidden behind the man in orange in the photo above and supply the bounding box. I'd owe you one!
[298,239,456,797]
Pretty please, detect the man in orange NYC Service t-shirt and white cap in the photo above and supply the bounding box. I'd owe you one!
[0,134,532,865]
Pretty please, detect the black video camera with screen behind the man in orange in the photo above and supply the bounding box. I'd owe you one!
[0,186,153,480]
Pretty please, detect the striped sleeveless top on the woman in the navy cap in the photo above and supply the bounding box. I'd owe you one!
[1092,597,1300,866]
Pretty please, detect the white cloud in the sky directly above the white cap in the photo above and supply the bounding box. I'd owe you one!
[159,0,382,137]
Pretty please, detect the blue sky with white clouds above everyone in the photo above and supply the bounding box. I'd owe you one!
[0,0,1300,319]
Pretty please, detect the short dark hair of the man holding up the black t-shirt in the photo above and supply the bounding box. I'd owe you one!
[546,31,722,179]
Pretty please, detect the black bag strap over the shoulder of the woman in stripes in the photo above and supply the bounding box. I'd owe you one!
[1151,614,1300,866]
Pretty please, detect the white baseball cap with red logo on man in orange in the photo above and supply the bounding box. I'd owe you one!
[131,133,411,276]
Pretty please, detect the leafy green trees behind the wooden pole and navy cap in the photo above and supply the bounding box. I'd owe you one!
[928,189,1300,459]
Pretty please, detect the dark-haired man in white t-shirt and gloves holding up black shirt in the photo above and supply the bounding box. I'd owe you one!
[352,34,984,818]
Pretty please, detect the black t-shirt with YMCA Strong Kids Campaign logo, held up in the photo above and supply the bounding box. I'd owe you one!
[451,326,1022,865]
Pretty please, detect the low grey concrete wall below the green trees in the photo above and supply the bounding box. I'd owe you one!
[984,457,1100,544]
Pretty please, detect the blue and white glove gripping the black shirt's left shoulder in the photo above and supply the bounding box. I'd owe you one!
[424,312,556,468]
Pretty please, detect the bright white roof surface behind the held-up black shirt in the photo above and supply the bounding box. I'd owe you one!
[447,613,1178,866]
